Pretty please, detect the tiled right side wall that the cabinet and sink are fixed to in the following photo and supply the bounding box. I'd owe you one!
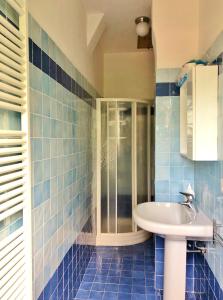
[195,32,223,299]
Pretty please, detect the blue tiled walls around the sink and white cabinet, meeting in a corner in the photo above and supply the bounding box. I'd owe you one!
[155,38,223,299]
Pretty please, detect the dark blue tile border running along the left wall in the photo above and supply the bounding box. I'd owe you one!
[29,38,96,108]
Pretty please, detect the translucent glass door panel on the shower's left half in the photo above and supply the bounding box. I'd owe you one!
[101,101,132,233]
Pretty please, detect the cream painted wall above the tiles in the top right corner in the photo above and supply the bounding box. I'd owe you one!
[199,0,223,55]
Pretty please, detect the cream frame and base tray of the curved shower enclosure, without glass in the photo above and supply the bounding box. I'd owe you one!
[96,98,152,246]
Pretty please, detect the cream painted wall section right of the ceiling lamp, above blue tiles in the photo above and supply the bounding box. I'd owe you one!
[152,0,199,69]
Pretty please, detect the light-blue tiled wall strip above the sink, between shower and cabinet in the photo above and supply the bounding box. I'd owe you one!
[155,69,194,202]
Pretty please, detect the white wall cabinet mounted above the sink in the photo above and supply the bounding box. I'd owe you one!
[180,65,218,161]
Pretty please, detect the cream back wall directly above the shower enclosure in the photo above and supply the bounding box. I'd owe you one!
[104,50,155,99]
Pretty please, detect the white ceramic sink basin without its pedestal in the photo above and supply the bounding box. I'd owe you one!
[133,202,213,239]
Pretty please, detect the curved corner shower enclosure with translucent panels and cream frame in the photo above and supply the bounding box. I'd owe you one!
[97,98,151,245]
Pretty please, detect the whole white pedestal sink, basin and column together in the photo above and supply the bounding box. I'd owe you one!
[133,202,213,300]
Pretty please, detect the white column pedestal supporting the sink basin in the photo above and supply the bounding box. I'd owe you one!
[164,236,187,300]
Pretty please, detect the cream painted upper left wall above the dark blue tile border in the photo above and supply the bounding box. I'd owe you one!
[28,0,103,93]
